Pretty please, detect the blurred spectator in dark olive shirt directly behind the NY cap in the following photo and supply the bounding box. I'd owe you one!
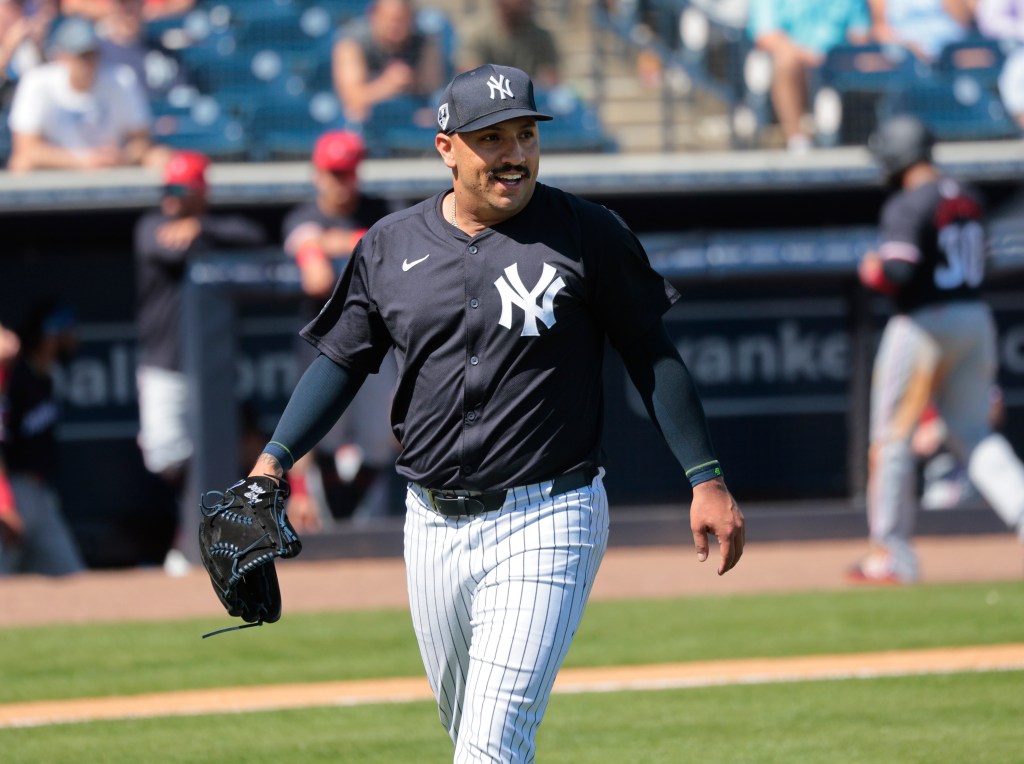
[459,0,561,88]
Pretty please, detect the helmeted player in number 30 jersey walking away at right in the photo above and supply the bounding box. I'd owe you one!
[850,110,1024,583]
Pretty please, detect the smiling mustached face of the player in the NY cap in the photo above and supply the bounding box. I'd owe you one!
[435,117,541,228]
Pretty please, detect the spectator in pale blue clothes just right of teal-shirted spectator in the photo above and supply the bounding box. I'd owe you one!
[868,0,976,60]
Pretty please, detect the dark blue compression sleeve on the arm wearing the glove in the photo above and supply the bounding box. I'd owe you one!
[263,353,367,472]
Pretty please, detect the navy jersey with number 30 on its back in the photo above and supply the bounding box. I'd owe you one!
[879,178,986,312]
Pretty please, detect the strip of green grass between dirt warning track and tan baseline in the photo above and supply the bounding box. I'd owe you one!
[0,583,1024,703]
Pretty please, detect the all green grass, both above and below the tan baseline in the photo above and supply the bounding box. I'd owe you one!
[0,583,1024,764]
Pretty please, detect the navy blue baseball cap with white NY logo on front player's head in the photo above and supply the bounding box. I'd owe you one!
[437,63,552,135]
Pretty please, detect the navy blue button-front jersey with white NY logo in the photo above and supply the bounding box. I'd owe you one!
[302,183,679,491]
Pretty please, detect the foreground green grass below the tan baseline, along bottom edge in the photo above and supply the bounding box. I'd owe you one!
[0,672,1024,764]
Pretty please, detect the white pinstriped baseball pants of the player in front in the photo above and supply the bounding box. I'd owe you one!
[406,471,608,764]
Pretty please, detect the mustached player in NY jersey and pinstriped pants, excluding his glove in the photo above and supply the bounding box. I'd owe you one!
[244,65,744,764]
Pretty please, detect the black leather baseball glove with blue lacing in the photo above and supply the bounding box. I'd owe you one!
[199,477,302,636]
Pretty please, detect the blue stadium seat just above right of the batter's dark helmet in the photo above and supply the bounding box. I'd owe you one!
[879,74,1021,141]
